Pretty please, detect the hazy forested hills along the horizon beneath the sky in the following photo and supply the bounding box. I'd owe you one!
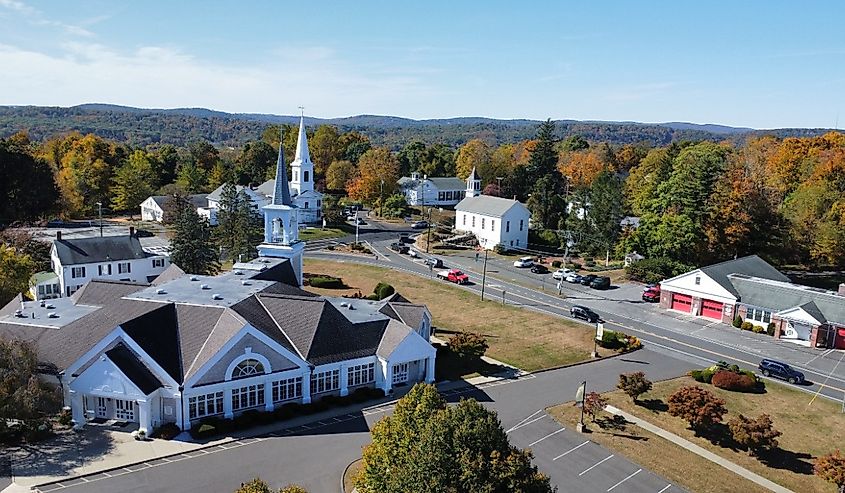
[0,104,827,149]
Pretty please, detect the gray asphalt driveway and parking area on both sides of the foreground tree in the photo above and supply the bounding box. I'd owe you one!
[42,349,691,493]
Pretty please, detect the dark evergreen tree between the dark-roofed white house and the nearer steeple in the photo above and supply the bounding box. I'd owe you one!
[170,197,220,275]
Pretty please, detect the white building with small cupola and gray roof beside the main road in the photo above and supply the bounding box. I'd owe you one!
[455,168,531,250]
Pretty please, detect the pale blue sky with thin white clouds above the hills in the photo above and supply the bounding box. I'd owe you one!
[0,0,845,128]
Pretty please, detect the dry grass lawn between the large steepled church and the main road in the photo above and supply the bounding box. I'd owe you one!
[305,259,612,371]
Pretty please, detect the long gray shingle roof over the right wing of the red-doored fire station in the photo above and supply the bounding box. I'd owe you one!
[730,275,845,324]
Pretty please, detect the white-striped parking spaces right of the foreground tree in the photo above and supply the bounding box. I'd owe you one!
[507,410,685,493]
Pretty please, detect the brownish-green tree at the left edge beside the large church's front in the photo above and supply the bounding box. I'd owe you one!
[0,338,61,428]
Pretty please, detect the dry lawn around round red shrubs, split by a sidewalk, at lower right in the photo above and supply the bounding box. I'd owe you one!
[551,377,845,493]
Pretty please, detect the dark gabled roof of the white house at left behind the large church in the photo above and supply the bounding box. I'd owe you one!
[53,235,151,266]
